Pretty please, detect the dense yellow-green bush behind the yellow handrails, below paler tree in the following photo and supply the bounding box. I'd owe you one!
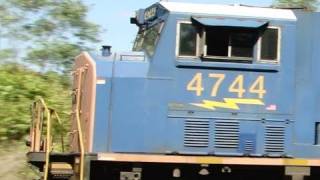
[0,64,71,140]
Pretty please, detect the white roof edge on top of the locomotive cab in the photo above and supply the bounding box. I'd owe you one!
[159,1,297,21]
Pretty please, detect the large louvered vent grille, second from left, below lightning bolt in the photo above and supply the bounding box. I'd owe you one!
[214,121,239,148]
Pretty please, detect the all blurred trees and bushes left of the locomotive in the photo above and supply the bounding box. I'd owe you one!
[0,0,101,179]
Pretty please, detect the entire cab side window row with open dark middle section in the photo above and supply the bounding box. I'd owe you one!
[177,18,280,63]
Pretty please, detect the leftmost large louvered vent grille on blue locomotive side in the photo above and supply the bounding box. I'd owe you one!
[184,120,210,148]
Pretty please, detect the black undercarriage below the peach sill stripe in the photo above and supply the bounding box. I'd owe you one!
[90,161,320,180]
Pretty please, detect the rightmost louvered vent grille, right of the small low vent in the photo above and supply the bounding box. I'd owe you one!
[265,126,285,153]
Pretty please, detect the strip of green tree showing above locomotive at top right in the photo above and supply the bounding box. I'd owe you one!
[274,0,319,11]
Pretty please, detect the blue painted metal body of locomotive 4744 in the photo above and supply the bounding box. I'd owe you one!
[92,4,320,158]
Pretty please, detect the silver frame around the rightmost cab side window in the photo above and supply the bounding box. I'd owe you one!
[257,26,282,64]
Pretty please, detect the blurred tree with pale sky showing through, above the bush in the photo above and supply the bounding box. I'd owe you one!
[0,0,101,71]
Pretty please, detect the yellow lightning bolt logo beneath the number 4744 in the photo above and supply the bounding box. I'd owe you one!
[191,98,264,110]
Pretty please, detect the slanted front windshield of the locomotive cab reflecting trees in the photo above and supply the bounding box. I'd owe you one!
[133,23,163,56]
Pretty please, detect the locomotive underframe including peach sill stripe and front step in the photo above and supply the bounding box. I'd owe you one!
[28,153,320,180]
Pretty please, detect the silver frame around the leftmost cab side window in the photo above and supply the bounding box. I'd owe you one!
[176,20,200,59]
